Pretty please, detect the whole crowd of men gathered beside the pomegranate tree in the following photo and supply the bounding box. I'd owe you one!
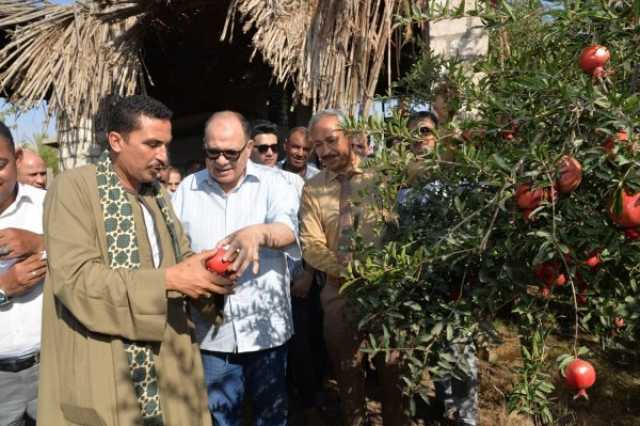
[0,96,477,426]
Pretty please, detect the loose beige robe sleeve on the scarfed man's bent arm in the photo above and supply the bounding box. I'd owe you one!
[44,171,167,341]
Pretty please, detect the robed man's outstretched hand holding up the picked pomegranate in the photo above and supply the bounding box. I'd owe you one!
[165,250,235,299]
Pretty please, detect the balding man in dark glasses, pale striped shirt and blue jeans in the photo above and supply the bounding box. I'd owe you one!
[173,111,300,426]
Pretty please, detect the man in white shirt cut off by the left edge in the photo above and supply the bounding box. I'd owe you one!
[0,122,46,426]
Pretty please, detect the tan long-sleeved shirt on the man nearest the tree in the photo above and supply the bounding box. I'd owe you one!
[300,169,374,278]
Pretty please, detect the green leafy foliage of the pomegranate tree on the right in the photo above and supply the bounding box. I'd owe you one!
[344,1,640,424]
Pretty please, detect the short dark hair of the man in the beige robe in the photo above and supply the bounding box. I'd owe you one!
[95,95,173,143]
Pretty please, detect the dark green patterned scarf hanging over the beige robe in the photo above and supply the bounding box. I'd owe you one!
[96,151,181,426]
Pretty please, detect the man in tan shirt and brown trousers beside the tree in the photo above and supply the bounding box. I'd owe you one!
[300,110,406,426]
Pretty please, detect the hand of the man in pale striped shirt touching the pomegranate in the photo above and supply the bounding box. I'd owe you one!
[217,225,266,280]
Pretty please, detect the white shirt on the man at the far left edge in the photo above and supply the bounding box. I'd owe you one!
[0,184,46,359]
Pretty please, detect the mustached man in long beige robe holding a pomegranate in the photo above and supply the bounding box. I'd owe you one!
[38,96,232,426]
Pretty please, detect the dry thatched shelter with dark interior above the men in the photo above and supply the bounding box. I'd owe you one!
[0,0,400,168]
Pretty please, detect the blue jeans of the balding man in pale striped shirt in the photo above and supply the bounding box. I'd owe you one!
[202,343,288,426]
